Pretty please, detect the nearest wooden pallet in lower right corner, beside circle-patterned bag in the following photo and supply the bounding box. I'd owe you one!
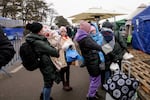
[124,61,150,100]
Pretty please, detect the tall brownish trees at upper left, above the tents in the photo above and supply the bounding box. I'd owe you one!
[0,0,56,23]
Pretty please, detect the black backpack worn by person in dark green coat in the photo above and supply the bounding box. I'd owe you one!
[19,42,40,71]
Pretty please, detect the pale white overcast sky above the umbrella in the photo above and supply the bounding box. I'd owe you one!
[45,0,150,22]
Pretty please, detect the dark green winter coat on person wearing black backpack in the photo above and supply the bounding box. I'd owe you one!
[26,33,61,87]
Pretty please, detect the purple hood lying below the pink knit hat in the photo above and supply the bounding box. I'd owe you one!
[74,29,88,42]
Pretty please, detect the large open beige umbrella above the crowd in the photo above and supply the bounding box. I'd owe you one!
[69,8,125,22]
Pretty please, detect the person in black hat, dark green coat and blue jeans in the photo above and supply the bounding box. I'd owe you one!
[25,22,61,100]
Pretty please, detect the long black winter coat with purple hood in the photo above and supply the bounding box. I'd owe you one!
[75,29,101,77]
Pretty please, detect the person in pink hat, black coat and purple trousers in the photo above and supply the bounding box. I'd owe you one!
[74,21,102,100]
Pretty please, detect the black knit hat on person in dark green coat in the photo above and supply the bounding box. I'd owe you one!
[26,22,43,33]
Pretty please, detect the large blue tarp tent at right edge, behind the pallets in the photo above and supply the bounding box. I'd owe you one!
[132,6,150,54]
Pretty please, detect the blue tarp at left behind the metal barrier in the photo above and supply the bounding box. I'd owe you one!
[3,28,24,40]
